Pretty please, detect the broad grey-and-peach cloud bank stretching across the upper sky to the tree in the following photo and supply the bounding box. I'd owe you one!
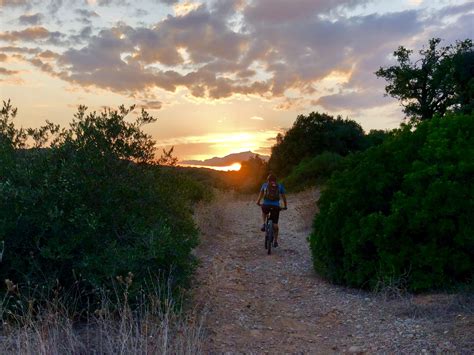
[0,0,474,115]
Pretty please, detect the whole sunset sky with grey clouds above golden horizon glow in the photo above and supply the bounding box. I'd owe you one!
[0,0,474,160]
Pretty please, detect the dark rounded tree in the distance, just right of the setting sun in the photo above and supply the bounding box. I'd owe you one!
[268,112,364,176]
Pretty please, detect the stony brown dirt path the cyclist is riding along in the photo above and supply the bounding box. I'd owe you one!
[195,190,474,354]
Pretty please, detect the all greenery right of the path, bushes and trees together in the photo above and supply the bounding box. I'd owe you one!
[269,39,474,292]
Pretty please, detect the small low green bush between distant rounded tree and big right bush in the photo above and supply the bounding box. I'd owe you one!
[282,152,343,191]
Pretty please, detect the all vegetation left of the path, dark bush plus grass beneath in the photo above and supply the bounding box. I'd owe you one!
[0,102,207,353]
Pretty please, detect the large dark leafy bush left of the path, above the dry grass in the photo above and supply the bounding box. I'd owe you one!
[0,104,205,308]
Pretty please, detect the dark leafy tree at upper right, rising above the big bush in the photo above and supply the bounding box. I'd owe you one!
[375,38,474,120]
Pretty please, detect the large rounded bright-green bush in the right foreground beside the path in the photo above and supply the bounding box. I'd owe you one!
[310,114,474,291]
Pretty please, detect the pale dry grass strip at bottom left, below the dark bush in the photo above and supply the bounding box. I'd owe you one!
[0,280,203,355]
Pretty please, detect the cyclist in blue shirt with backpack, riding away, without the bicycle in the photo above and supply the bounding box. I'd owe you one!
[257,173,288,247]
